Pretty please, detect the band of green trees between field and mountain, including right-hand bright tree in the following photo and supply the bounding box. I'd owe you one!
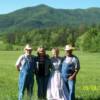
[2,25,100,52]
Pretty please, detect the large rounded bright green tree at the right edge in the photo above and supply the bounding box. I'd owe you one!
[76,28,100,52]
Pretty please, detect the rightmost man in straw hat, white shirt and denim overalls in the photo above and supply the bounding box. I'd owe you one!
[61,45,80,100]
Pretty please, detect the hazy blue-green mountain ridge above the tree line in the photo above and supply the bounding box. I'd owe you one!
[0,4,100,34]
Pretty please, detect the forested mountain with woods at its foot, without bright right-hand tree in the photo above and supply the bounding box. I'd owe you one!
[0,5,100,50]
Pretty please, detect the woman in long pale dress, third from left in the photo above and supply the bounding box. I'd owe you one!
[47,48,68,100]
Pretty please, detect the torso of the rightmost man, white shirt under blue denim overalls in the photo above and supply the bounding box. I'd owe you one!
[61,55,80,81]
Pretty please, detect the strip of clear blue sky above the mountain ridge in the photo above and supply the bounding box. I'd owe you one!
[0,0,100,14]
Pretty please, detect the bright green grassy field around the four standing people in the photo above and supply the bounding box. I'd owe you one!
[0,51,100,100]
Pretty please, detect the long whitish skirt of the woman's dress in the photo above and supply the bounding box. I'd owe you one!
[47,71,68,100]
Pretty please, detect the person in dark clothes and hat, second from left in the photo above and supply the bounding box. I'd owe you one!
[36,47,51,100]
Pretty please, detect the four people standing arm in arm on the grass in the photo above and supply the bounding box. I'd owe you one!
[16,44,80,100]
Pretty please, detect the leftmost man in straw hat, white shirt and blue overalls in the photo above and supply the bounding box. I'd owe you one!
[16,44,35,100]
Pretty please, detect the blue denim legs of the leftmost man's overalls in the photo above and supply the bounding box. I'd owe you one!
[18,72,34,100]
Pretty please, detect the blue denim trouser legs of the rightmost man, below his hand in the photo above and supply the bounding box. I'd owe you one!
[66,80,75,100]
